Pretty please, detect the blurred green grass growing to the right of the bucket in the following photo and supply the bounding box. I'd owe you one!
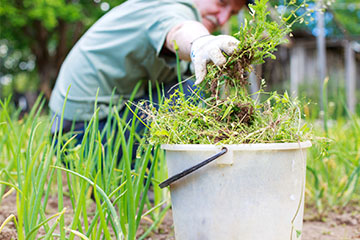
[306,115,360,215]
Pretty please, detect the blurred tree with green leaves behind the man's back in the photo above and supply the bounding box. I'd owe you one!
[0,0,124,101]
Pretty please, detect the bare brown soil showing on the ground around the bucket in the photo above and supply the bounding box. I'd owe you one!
[0,194,360,240]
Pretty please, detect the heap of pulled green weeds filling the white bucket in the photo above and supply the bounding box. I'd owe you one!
[150,89,310,144]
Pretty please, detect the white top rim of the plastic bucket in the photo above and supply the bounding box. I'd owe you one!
[161,141,312,151]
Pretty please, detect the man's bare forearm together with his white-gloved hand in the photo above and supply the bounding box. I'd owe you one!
[165,21,239,85]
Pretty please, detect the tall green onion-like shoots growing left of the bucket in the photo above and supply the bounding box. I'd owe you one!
[0,94,169,239]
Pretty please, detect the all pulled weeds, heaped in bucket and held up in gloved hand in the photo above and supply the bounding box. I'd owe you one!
[143,0,311,144]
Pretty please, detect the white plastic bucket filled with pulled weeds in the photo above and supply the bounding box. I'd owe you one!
[162,141,311,240]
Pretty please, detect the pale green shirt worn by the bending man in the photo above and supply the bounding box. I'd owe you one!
[49,0,200,121]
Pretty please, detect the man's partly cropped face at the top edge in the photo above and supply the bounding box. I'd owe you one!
[194,0,247,32]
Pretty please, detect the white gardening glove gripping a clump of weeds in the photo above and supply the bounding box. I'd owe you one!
[190,35,239,85]
